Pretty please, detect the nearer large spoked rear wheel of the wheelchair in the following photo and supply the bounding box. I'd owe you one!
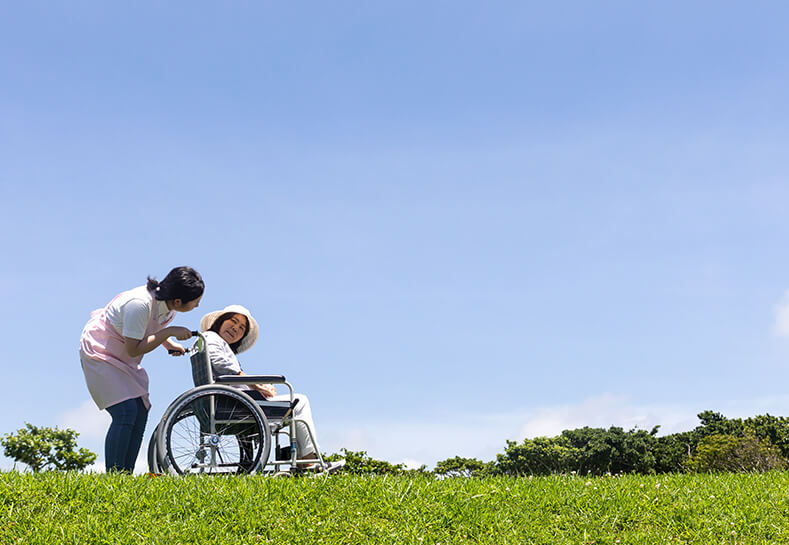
[157,386,271,474]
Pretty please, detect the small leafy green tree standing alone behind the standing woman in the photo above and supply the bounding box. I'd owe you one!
[0,422,96,471]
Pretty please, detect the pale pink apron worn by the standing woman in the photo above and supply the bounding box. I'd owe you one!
[80,297,173,409]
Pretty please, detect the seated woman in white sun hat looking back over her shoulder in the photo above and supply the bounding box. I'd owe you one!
[200,305,344,471]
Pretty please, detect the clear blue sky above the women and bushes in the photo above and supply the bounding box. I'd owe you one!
[0,1,789,467]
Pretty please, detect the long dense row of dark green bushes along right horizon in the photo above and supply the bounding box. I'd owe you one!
[495,411,789,475]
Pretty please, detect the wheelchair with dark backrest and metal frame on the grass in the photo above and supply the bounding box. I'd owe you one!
[148,331,328,476]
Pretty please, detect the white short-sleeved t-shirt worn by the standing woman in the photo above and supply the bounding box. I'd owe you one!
[107,286,175,340]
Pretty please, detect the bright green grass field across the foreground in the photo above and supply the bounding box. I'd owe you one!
[0,472,789,545]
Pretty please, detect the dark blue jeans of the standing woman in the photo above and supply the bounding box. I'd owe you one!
[104,397,148,473]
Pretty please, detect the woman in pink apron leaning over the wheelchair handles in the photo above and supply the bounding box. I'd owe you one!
[79,267,205,473]
